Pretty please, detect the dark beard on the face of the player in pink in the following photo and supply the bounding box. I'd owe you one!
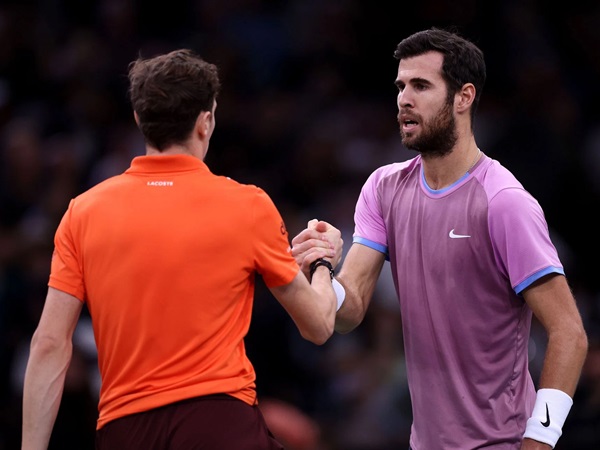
[400,102,458,157]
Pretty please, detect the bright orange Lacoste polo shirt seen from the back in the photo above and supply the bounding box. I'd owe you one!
[49,155,299,429]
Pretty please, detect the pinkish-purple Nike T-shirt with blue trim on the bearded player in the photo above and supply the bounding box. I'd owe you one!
[353,154,564,450]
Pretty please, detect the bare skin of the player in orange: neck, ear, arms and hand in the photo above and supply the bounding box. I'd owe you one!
[21,102,342,450]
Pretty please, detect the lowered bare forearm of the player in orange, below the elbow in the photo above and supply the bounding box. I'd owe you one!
[21,341,72,450]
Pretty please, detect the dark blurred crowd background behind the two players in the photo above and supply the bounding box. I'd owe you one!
[0,0,600,450]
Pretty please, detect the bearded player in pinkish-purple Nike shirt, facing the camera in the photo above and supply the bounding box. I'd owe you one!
[292,28,587,450]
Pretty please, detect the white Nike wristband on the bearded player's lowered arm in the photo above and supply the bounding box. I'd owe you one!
[523,389,573,448]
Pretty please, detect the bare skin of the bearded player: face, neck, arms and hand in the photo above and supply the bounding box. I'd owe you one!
[292,52,588,450]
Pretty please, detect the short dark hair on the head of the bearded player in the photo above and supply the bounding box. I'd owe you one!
[394,27,486,127]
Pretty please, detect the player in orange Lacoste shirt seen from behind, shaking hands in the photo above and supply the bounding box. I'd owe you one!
[22,49,341,450]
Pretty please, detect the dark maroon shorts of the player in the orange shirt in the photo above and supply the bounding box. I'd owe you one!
[96,394,283,450]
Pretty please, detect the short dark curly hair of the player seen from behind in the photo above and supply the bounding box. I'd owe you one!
[129,49,221,150]
